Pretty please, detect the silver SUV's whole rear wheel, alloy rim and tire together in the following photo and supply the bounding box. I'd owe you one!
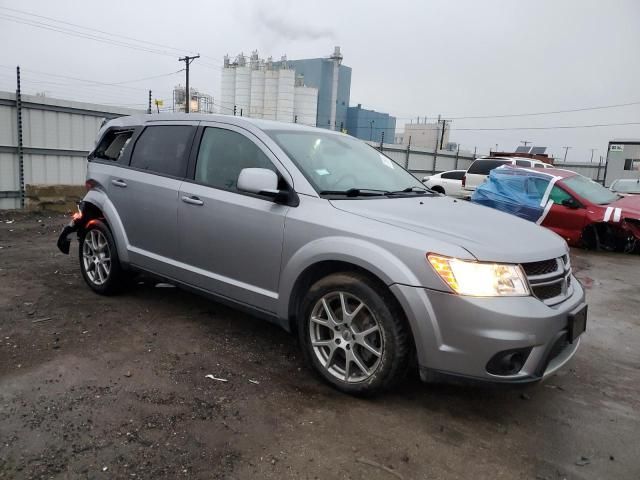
[79,220,122,295]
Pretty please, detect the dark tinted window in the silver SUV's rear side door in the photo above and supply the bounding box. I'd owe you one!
[131,125,195,177]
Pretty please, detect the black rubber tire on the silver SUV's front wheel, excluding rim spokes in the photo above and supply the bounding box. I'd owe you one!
[298,272,411,395]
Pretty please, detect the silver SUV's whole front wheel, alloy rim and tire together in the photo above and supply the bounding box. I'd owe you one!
[299,273,410,394]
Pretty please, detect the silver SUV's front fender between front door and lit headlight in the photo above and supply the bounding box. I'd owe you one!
[278,195,470,319]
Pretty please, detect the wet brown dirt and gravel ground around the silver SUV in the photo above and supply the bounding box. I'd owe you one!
[0,212,640,480]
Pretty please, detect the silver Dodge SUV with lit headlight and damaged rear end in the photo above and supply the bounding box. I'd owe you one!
[58,114,586,393]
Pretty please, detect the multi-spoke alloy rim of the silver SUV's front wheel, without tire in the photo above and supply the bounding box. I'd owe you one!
[309,292,384,383]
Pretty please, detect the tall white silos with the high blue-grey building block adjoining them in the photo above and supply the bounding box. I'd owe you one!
[220,47,351,130]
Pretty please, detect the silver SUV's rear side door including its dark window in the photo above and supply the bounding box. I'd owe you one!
[108,122,197,276]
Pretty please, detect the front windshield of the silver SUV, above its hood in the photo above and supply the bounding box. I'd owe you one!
[267,130,425,196]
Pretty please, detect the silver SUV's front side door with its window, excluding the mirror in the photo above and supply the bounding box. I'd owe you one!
[178,124,291,312]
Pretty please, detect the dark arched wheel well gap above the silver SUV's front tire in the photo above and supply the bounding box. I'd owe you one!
[288,260,416,358]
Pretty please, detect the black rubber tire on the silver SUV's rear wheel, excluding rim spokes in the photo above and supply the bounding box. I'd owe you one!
[78,220,125,295]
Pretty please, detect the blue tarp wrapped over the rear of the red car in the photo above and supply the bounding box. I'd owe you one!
[471,166,552,222]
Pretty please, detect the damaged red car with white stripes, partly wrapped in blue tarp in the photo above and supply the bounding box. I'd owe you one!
[472,167,640,251]
